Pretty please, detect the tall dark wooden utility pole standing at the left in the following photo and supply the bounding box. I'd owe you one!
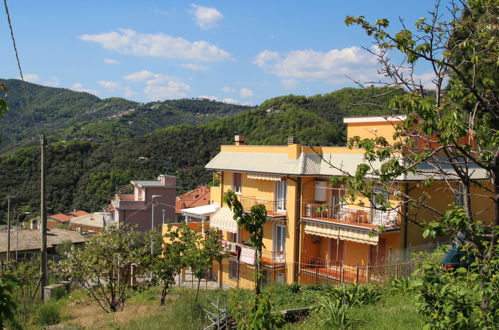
[40,135,47,301]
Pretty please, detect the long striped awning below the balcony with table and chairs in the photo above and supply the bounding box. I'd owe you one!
[305,222,379,245]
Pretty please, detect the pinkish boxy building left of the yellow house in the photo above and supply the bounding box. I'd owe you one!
[111,174,177,231]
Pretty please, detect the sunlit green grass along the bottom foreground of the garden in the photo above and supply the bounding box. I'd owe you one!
[6,285,423,330]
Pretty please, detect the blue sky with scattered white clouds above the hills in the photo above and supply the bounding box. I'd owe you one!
[0,0,446,104]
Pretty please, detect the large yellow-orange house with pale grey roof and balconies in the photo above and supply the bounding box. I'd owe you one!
[188,117,492,288]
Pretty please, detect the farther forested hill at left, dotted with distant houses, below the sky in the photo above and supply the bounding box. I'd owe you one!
[0,79,251,153]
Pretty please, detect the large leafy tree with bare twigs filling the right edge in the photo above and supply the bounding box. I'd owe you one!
[342,0,499,328]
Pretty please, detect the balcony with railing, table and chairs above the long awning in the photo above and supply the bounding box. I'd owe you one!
[302,203,400,229]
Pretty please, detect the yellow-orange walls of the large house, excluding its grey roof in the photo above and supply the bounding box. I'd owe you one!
[198,115,493,288]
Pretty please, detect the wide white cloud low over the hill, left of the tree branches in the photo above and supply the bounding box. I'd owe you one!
[253,46,380,84]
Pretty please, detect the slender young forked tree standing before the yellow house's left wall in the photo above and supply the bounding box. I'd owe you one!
[224,190,267,295]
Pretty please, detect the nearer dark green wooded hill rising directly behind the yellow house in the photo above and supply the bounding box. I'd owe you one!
[0,85,400,219]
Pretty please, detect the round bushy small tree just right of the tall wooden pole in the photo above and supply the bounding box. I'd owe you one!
[54,226,149,313]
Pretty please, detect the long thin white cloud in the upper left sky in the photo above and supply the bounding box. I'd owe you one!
[79,29,232,62]
